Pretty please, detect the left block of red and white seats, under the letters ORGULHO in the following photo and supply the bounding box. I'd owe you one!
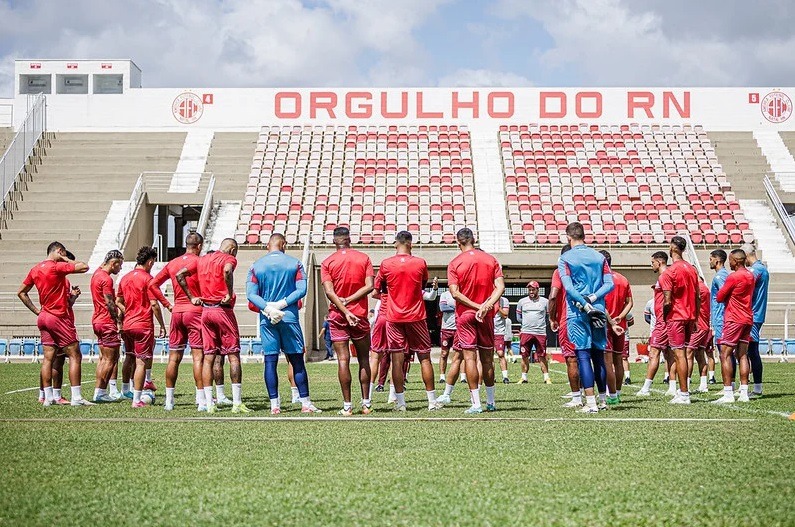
[236,125,477,245]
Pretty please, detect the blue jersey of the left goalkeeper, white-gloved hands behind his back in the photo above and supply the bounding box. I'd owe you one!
[246,251,306,324]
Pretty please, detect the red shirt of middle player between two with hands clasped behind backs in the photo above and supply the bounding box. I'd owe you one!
[375,254,428,322]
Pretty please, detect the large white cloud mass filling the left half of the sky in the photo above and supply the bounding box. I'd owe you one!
[0,0,450,96]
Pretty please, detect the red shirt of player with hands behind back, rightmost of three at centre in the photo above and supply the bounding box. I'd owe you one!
[447,249,502,316]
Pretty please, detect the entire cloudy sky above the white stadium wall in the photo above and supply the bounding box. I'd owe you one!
[0,0,795,97]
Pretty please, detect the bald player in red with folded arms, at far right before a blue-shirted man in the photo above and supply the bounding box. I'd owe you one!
[713,249,755,404]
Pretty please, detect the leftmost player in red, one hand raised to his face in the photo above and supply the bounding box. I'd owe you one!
[17,242,94,406]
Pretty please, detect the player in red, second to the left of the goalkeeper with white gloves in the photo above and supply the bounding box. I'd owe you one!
[149,232,207,412]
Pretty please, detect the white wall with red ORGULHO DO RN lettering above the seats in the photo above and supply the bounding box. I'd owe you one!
[14,87,795,131]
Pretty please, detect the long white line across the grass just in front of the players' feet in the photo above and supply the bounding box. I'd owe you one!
[0,416,756,423]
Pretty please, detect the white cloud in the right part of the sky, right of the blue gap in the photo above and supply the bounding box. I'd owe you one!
[497,0,795,86]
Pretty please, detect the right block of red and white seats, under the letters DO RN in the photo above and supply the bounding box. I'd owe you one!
[499,124,753,245]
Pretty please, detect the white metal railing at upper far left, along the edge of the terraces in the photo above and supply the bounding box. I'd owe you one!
[0,94,47,219]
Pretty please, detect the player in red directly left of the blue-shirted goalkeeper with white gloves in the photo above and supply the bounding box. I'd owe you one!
[177,238,251,414]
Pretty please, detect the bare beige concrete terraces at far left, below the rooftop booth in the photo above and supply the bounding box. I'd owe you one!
[0,133,185,338]
